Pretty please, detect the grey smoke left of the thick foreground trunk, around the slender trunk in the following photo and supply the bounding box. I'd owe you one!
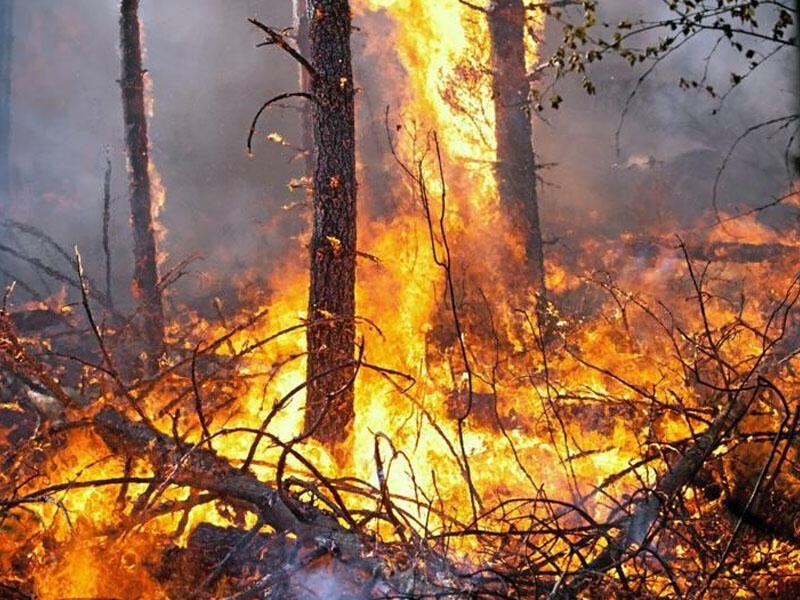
[2,0,305,310]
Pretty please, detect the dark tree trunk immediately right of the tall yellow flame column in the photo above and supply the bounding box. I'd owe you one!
[486,0,544,291]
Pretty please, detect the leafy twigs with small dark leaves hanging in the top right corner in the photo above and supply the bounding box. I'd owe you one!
[529,0,797,105]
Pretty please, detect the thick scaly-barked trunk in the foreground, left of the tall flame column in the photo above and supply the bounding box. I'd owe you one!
[305,0,356,444]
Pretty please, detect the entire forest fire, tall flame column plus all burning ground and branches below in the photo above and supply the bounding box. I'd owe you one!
[0,0,800,600]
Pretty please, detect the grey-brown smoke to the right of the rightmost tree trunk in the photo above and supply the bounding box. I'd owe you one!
[535,1,797,237]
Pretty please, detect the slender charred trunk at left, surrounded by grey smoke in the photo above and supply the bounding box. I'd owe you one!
[119,0,164,373]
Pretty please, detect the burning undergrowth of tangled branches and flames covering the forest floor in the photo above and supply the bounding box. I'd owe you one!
[2,189,800,598]
